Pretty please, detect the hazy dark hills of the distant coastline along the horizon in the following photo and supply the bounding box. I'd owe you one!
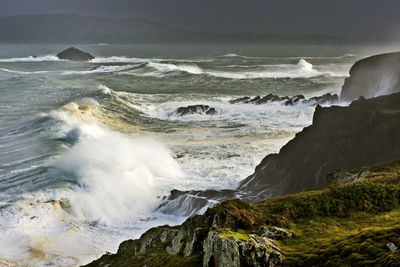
[0,14,398,45]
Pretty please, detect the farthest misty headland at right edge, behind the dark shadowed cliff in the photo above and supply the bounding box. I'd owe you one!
[340,52,400,102]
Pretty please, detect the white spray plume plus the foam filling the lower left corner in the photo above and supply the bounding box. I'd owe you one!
[0,102,183,266]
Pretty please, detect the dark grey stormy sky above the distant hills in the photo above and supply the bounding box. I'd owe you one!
[0,0,400,36]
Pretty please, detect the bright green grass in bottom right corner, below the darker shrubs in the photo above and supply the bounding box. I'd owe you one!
[278,211,400,266]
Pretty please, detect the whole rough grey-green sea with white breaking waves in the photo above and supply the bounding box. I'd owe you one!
[0,44,376,266]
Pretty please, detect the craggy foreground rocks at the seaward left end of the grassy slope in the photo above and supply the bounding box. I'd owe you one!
[87,200,285,267]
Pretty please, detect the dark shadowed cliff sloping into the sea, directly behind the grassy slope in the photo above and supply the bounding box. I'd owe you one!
[239,93,400,202]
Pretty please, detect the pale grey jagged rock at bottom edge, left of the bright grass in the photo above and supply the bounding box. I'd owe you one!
[203,231,283,267]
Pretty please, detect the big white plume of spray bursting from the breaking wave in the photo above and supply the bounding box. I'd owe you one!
[49,99,182,223]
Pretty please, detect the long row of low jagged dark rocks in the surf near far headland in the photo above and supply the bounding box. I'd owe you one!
[229,93,338,106]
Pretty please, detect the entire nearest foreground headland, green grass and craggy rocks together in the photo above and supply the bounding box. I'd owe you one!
[87,161,400,267]
